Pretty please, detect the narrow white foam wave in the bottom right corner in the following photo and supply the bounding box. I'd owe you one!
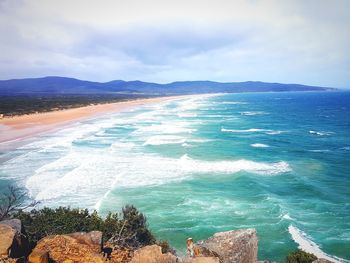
[288,225,350,263]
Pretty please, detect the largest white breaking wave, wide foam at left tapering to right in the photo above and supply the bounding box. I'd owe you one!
[25,149,291,208]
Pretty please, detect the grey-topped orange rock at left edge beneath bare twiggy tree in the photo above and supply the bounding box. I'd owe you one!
[0,219,30,258]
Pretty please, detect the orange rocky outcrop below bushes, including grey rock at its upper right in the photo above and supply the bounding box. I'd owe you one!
[29,231,104,263]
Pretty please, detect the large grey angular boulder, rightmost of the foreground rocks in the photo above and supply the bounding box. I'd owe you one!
[196,229,258,263]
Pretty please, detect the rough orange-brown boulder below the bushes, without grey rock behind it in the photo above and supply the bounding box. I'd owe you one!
[32,235,104,263]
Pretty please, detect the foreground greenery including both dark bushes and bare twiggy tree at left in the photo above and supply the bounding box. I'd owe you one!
[0,186,169,252]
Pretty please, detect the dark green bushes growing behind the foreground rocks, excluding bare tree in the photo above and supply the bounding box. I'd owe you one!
[13,206,155,251]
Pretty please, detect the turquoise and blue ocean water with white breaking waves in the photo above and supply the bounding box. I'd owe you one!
[0,92,350,262]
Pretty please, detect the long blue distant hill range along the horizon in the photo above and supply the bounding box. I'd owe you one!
[0,77,334,95]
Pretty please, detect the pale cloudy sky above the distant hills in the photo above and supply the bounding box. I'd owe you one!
[0,0,350,88]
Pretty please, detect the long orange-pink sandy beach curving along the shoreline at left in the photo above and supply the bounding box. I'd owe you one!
[0,96,185,144]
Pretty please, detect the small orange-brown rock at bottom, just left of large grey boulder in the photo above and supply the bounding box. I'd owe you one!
[130,245,177,263]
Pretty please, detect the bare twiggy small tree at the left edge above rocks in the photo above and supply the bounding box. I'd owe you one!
[0,186,39,221]
